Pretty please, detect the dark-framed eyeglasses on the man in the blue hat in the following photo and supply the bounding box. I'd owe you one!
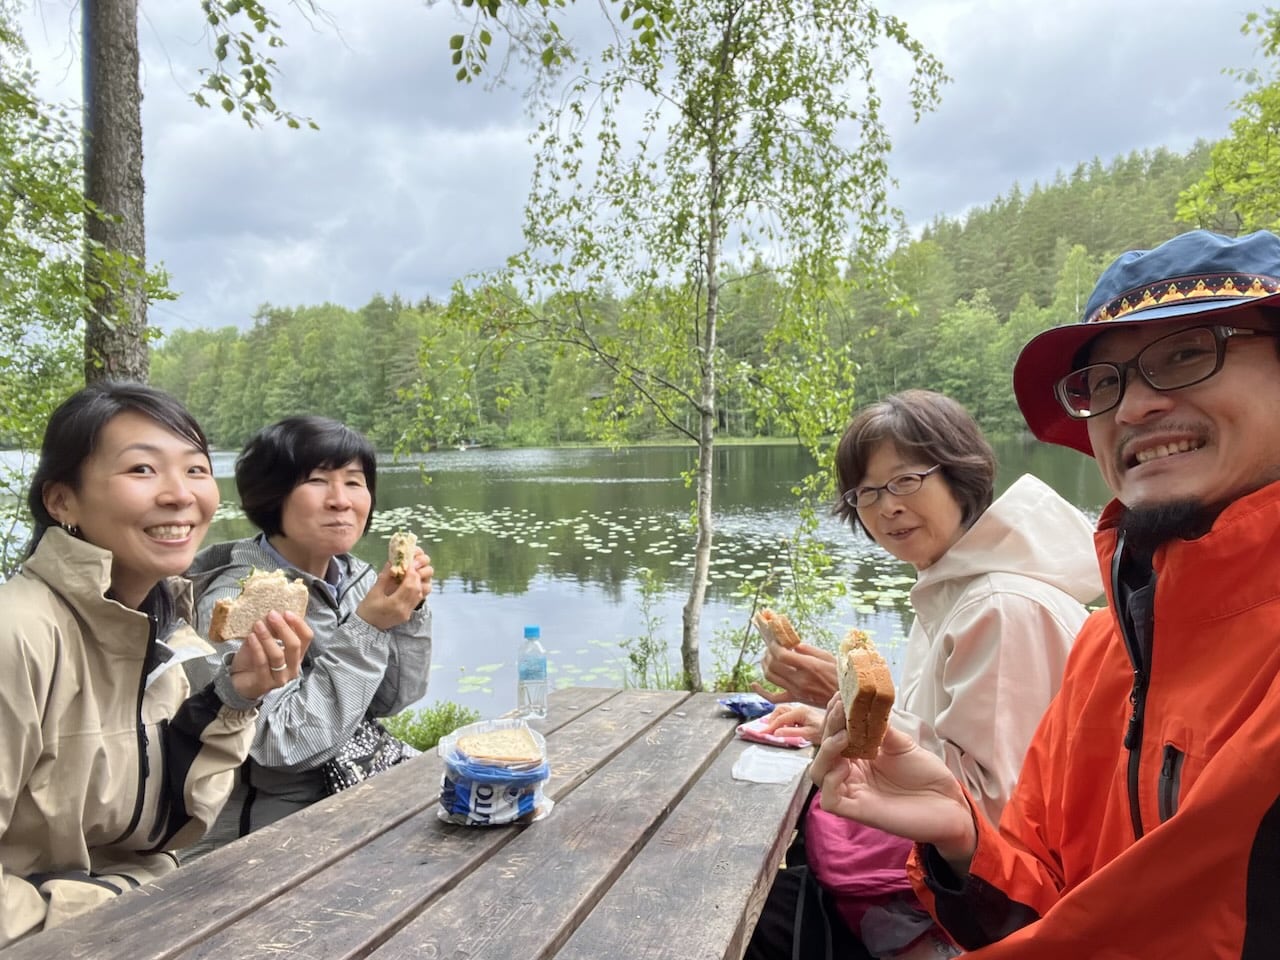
[1053,325,1275,420]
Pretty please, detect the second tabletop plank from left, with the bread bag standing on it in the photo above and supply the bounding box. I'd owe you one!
[171,690,689,960]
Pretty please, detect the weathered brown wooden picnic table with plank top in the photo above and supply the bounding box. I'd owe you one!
[4,687,808,960]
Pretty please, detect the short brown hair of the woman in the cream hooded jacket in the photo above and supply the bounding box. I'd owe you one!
[832,390,996,536]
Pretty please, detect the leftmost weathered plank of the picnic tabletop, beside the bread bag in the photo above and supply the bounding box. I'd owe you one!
[5,687,640,960]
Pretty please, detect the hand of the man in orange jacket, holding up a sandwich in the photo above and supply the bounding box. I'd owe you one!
[809,694,978,878]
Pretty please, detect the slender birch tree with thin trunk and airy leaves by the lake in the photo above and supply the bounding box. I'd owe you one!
[448,0,945,690]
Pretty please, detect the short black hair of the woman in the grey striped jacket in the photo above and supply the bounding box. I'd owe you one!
[236,416,378,536]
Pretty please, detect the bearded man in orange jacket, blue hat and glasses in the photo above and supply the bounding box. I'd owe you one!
[812,230,1280,960]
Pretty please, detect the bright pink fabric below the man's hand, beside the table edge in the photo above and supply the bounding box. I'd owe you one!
[804,794,914,933]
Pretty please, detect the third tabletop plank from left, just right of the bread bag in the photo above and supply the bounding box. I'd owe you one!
[370,709,733,960]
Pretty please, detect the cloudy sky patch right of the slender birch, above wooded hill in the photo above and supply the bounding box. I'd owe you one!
[893,0,1252,223]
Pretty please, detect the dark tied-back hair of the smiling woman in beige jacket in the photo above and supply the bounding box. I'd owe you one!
[27,380,209,557]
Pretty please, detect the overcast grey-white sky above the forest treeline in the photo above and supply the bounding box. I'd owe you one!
[22,0,1260,329]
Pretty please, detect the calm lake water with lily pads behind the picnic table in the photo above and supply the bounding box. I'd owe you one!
[0,443,1107,716]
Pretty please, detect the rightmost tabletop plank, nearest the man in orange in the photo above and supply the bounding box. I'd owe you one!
[556,696,809,960]
